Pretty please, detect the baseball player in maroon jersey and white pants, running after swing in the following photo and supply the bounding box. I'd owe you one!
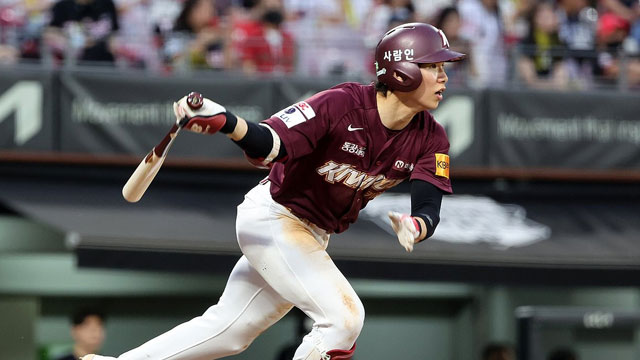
[83,23,465,360]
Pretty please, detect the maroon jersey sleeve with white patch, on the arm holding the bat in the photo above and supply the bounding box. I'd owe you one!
[264,89,351,159]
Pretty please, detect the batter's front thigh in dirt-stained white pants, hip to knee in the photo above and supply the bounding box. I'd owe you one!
[238,206,363,322]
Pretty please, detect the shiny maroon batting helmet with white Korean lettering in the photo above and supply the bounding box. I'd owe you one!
[376,23,466,91]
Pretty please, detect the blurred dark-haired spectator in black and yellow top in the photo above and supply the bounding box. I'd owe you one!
[517,1,568,89]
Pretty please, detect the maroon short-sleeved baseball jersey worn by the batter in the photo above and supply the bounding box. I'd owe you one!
[264,83,451,232]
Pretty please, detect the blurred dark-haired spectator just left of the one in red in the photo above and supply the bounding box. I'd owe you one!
[164,0,227,70]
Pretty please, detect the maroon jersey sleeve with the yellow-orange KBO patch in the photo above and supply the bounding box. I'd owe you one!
[411,120,453,193]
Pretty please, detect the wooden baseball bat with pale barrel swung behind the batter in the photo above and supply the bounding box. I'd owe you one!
[122,92,202,203]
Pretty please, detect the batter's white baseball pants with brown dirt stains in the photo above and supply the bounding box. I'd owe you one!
[118,183,364,360]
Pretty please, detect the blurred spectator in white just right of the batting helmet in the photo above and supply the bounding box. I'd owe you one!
[458,0,507,87]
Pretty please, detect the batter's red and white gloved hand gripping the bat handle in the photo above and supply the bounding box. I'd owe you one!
[173,92,227,134]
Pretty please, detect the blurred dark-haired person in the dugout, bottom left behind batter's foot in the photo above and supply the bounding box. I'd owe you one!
[57,309,105,360]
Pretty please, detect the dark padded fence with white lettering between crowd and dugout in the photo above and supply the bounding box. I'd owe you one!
[0,69,640,175]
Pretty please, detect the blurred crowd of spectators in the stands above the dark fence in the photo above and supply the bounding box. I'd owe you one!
[0,0,640,89]
